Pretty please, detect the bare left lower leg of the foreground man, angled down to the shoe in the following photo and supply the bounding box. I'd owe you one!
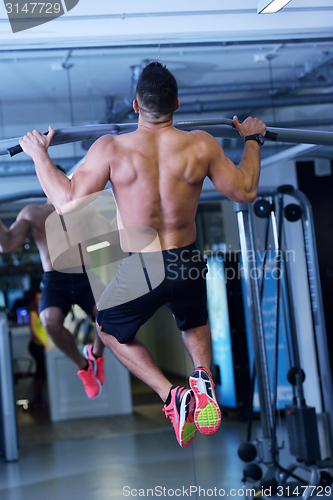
[97,325,172,402]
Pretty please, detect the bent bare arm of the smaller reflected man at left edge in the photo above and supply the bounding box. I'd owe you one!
[0,208,32,253]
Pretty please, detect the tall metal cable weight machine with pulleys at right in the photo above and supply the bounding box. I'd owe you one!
[235,186,333,499]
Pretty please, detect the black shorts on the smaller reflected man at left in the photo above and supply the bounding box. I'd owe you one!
[38,271,96,316]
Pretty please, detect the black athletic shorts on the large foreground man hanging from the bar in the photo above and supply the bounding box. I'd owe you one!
[96,243,208,344]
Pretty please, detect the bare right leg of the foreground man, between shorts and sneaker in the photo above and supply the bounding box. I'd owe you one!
[182,323,212,372]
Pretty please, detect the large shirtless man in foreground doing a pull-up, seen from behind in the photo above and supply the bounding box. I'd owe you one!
[20,63,266,447]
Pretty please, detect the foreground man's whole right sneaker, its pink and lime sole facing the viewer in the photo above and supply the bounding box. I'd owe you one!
[189,367,221,434]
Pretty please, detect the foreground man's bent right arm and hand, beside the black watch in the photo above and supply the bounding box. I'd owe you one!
[207,117,266,203]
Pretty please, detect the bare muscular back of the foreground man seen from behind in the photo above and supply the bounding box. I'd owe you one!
[108,126,209,249]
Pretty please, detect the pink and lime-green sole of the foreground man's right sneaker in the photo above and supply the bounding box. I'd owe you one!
[189,376,221,435]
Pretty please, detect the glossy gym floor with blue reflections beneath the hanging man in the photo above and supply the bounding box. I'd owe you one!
[0,376,331,500]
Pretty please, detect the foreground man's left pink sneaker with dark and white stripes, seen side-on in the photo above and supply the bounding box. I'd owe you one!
[163,385,197,448]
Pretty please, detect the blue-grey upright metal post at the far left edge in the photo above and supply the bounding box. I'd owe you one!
[0,311,18,462]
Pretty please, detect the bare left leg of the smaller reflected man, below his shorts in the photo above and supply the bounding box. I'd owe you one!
[40,307,87,370]
